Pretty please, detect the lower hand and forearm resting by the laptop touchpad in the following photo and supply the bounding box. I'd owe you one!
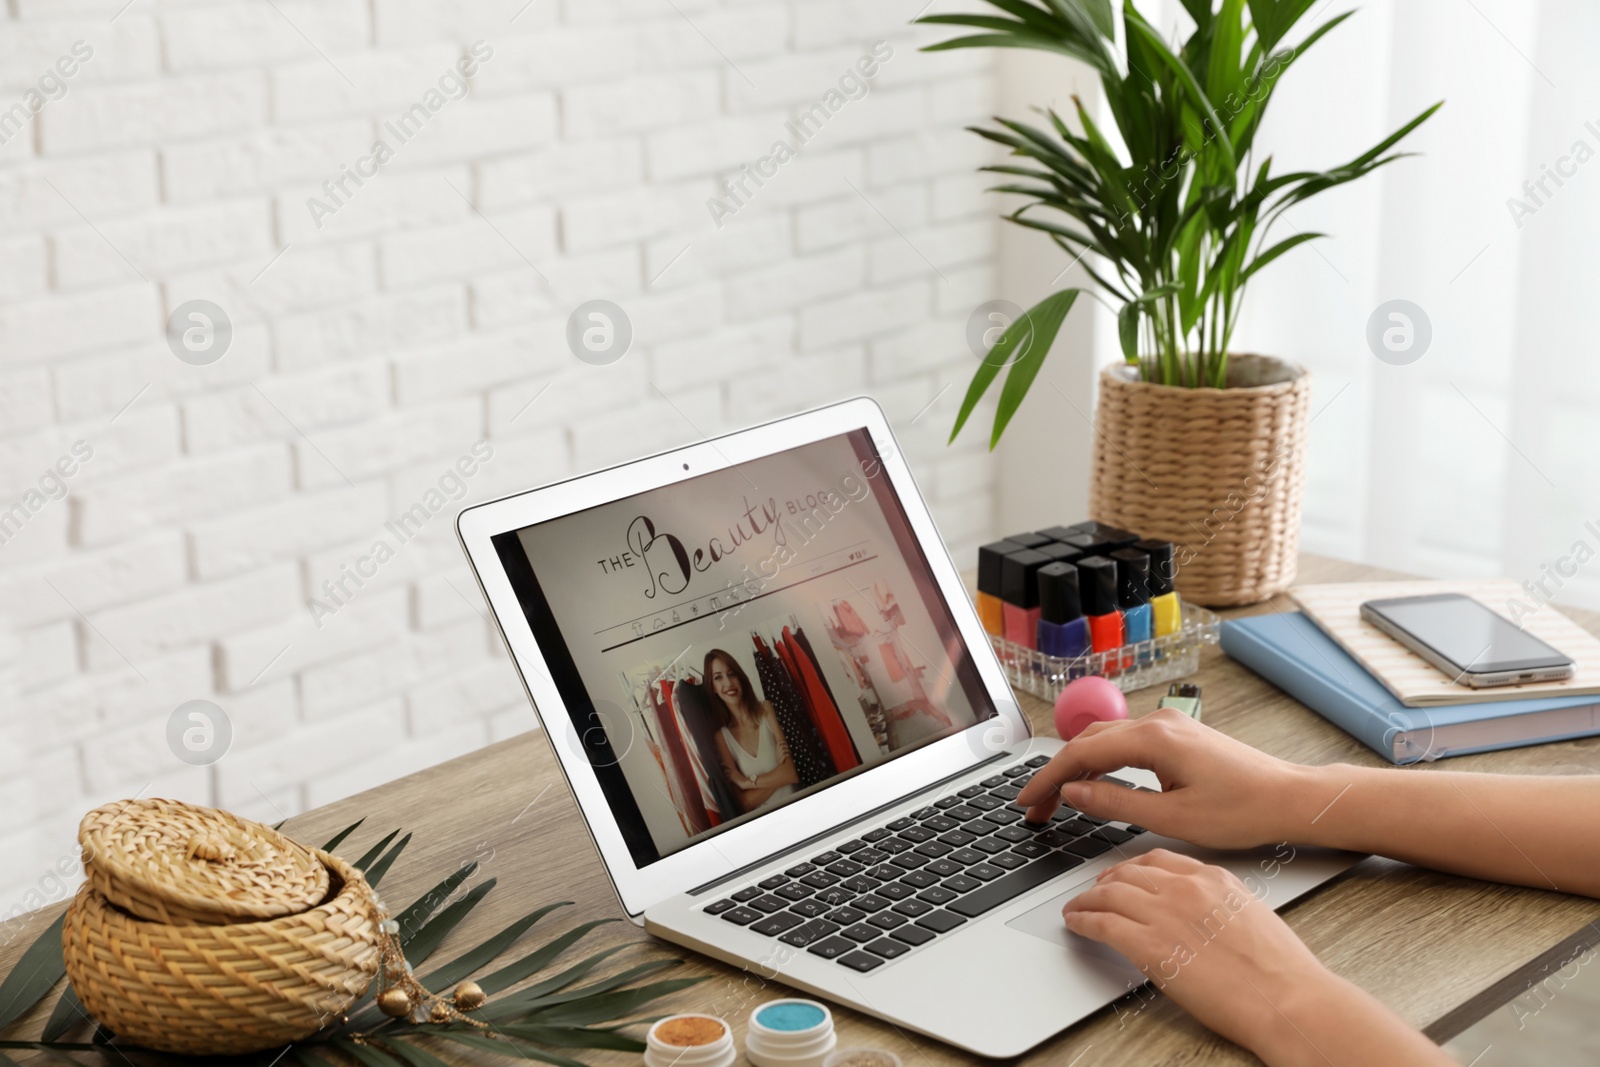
[1062,848,1451,1067]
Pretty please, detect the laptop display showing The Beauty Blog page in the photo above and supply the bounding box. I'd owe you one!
[494,429,997,867]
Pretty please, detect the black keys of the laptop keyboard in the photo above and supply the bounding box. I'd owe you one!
[704,755,1144,973]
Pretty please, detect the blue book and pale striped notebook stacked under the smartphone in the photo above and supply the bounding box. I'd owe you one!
[1222,582,1600,763]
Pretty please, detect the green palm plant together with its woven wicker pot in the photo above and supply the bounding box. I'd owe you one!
[918,0,1440,605]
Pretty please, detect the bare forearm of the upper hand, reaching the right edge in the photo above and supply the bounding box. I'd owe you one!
[1285,763,1600,897]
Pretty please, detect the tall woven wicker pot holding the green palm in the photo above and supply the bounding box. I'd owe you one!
[1090,355,1310,608]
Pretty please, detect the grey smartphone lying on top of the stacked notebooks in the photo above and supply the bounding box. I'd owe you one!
[1362,593,1573,689]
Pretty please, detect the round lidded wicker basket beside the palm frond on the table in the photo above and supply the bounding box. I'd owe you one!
[62,800,381,1054]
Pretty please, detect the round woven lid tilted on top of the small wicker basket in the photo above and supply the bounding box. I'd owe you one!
[78,800,328,925]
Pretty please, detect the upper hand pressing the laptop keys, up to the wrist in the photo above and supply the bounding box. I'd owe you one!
[1016,709,1339,848]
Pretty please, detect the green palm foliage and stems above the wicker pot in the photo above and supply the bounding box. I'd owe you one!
[918,0,1438,448]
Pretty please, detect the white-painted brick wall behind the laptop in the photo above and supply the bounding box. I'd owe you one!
[0,0,997,918]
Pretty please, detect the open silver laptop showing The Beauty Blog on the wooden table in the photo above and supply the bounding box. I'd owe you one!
[458,398,1357,1057]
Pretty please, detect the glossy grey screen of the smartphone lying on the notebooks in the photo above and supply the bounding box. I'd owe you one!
[1366,593,1571,673]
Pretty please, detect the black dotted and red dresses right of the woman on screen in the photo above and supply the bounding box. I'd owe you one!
[750,614,861,787]
